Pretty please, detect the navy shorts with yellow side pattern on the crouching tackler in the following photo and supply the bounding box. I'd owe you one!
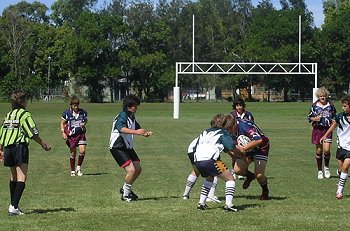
[194,159,228,177]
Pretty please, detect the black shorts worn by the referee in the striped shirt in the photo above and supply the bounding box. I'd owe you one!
[4,143,29,167]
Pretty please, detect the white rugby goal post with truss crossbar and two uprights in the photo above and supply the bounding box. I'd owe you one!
[173,15,317,119]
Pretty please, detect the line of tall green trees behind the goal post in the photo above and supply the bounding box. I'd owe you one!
[0,0,350,102]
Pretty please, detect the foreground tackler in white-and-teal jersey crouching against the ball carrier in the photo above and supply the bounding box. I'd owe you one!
[188,114,245,212]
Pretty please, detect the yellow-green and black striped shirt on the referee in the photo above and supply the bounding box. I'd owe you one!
[0,108,39,147]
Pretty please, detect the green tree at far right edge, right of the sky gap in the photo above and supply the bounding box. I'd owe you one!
[319,1,350,96]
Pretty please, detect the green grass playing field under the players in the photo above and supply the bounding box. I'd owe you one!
[0,99,350,231]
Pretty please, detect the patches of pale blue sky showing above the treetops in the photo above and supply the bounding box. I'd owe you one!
[0,0,324,27]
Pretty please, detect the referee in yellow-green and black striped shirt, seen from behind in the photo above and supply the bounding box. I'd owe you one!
[0,91,51,215]
